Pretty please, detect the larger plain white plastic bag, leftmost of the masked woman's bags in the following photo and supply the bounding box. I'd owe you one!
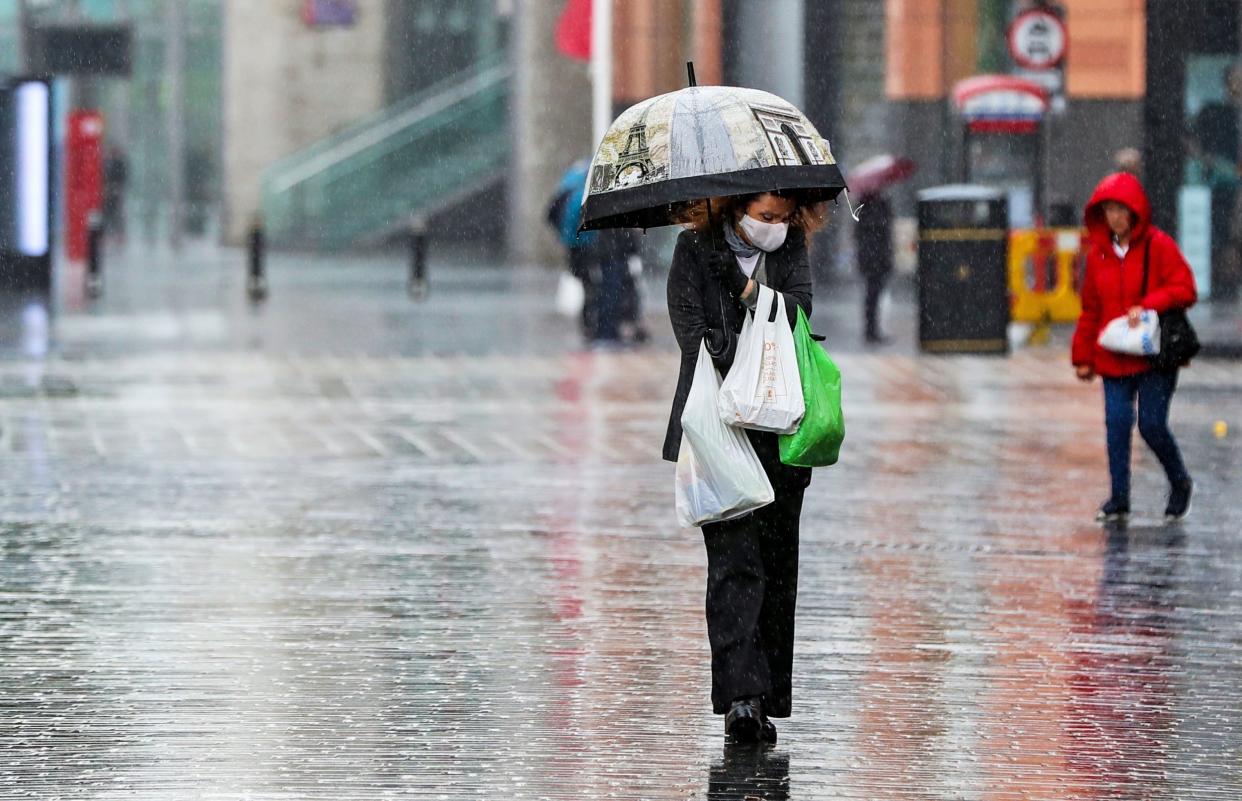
[677,344,776,528]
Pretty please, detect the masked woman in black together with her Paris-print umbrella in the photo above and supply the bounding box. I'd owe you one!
[582,75,845,743]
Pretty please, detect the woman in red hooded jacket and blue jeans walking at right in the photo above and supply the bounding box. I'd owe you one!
[1073,173,1197,522]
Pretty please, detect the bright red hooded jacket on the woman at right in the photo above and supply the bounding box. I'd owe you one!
[1072,173,1197,378]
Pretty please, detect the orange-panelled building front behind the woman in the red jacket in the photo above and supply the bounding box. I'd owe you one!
[879,0,1242,302]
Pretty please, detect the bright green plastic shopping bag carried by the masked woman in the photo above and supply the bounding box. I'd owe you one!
[780,308,846,467]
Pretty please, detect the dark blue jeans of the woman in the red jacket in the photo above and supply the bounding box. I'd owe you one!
[1104,370,1190,502]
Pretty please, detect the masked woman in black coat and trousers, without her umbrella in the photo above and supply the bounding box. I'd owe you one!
[663,192,822,743]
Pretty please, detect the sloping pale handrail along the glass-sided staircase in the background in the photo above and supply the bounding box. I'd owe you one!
[266,63,512,194]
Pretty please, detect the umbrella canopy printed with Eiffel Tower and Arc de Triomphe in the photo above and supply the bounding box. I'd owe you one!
[582,86,846,231]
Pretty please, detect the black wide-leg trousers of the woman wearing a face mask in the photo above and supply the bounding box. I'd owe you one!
[703,435,810,718]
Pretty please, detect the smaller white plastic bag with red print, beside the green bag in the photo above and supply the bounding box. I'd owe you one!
[720,284,806,433]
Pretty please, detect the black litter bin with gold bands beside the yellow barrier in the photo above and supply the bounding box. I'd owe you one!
[918,185,1010,354]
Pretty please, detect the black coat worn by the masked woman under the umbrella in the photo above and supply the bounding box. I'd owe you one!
[663,229,812,474]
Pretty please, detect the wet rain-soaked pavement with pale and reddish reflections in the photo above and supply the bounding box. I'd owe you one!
[0,248,1242,801]
